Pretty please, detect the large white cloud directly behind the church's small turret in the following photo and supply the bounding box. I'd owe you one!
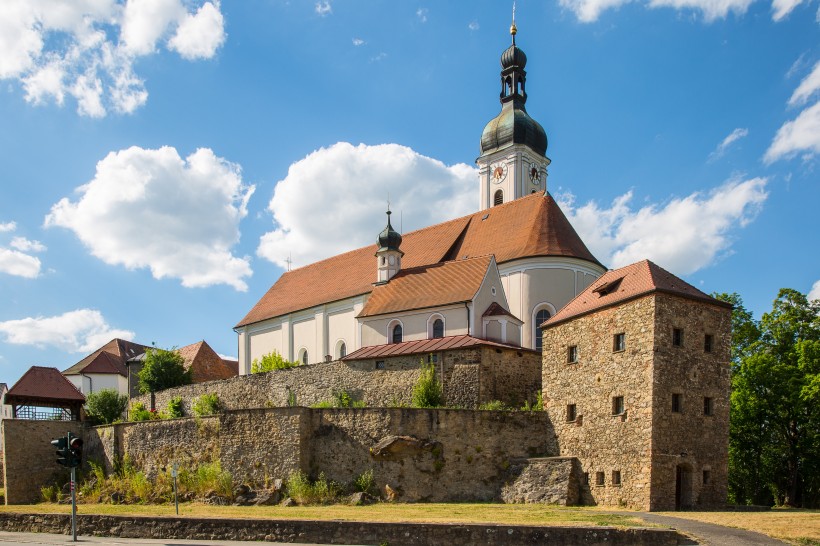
[257,142,478,268]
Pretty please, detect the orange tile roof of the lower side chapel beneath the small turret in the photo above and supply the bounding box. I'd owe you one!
[359,256,492,317]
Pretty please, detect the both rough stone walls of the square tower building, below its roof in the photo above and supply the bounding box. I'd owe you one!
[543,293,731,510]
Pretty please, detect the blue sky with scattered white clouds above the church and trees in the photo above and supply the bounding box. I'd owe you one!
[0,0,820,384]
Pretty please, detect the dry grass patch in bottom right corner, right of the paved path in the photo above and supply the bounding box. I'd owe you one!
[663,508,820,546]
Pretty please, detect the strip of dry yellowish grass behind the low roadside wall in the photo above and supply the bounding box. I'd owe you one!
[0,503,647,527]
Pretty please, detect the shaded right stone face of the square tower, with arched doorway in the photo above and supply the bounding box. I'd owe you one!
[651,294,731,510]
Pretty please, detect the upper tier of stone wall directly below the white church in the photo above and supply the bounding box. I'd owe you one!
[132,347,541,415]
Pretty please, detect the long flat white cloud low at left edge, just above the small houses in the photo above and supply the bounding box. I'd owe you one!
[0,309,134,353]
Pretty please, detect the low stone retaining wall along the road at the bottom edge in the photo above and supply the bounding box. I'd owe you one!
[0,512,688,546]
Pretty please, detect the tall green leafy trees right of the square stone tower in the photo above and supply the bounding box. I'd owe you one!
[729,288,820,507]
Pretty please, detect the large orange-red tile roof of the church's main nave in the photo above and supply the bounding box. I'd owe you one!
[237,194,600,327]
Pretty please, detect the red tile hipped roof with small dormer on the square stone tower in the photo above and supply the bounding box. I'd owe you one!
[543,260,732,328]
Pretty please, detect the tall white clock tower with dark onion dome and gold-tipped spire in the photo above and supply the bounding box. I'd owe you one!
[476,12,550,210]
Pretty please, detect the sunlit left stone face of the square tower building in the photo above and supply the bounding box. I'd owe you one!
[543,297,655,509]
